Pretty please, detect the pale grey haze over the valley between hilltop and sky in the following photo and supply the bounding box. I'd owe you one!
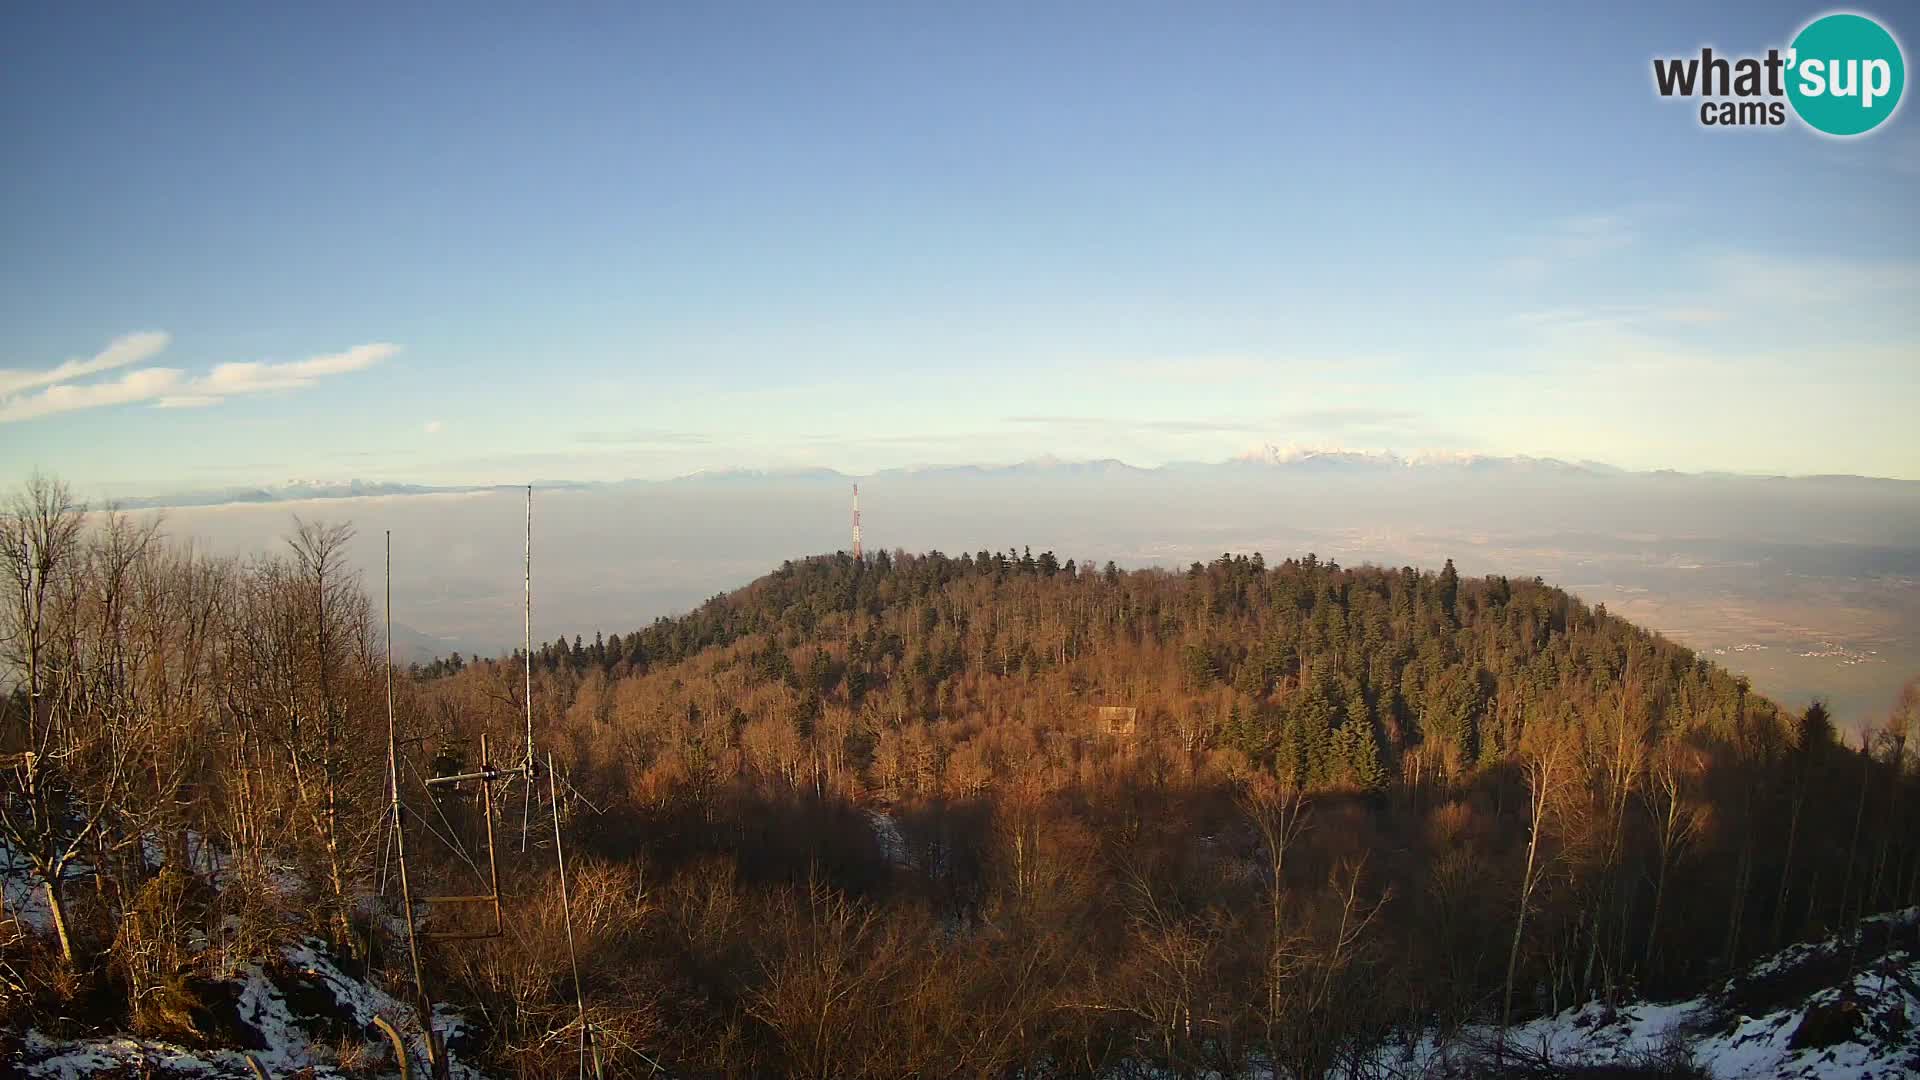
[142,455,1920,726]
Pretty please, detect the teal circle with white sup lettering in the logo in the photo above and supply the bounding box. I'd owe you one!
[1788,13,1907,136]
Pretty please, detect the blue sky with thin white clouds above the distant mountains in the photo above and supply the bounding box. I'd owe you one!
[0,4,1920,494]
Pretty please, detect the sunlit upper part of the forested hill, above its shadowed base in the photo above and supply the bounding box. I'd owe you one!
[445,552,1791,788]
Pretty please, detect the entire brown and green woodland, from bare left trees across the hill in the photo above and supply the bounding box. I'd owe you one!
[0,479,1920,1076]
